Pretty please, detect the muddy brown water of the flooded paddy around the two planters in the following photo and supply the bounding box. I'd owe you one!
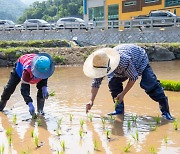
[0,61,180,154]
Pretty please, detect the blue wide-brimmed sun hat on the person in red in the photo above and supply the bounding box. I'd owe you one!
[31,53,55,79]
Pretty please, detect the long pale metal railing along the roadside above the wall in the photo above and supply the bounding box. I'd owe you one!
[0,17,180,31]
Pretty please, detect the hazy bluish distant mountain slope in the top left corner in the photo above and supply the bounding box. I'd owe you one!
[0,0,27,21]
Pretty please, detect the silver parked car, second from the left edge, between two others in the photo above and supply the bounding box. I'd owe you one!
[23,19,53,30]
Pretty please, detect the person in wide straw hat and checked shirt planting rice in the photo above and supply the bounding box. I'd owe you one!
[83,44,173,120]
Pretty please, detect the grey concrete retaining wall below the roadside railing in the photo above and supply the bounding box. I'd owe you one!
[0,27,180,45]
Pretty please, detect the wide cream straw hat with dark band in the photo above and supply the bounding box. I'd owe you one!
[83,48,120,78]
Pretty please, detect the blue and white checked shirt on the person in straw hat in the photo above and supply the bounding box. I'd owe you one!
[92,44,149,88]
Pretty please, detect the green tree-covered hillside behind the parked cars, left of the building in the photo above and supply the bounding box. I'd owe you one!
[18,0,83,23]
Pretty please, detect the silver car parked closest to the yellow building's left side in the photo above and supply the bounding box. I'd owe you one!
[56,17,94,29]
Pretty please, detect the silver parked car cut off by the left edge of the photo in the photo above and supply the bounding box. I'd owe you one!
[0,20,22,30]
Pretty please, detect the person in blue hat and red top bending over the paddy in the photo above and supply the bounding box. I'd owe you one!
[0,53,55,115]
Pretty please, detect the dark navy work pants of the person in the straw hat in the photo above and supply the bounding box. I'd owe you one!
[109,65,167,102]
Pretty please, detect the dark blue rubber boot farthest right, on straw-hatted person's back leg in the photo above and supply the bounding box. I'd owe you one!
[159,97,174,120]
